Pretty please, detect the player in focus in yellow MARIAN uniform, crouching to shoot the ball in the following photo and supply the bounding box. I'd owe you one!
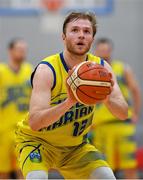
[17,12,128,179]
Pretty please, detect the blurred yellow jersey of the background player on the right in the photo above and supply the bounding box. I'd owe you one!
[93,60,132,126]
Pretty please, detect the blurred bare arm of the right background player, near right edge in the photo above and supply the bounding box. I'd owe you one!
[124,65,141,121]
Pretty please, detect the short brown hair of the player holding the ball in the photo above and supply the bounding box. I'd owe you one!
[63,12,97,37]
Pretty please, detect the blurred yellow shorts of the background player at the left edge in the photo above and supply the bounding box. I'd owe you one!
[0,132,18,173]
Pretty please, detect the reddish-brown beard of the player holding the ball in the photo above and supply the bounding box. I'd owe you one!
[67,43,91,56]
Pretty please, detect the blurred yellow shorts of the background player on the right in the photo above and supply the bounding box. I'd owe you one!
[91,123,137,170]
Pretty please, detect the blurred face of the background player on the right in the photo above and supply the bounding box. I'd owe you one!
[95,43,112,63]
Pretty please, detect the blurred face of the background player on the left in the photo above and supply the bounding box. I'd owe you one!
[9,41,27,63]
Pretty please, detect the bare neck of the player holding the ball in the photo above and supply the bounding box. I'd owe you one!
[63,51,87,69]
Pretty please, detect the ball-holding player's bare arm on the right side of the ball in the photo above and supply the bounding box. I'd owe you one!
[105,62,128,120]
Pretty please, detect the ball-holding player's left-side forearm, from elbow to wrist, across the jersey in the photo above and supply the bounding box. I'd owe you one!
[29,99,73,131]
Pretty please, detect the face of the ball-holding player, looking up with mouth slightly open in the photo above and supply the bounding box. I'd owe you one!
[63,19,94,55]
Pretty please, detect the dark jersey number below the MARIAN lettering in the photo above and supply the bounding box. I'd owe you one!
[73,119,88,136]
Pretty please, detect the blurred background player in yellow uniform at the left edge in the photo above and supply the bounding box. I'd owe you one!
[0,39,32,179]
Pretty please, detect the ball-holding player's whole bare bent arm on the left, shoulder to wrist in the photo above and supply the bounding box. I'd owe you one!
[29,64,76,130]
